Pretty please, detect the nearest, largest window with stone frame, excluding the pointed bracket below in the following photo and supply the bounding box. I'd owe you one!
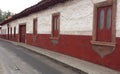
[92,0,117,45]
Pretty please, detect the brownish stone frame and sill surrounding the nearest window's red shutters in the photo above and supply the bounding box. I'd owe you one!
[91,0,117,46]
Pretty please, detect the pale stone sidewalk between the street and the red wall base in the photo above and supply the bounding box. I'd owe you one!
[1,40,120,74]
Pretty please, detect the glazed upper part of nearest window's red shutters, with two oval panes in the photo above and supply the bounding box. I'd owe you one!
[98,6,112,30]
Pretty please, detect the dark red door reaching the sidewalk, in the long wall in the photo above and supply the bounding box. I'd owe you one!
[19,25,26,43]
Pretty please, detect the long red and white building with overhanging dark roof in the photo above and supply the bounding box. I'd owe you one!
[0,0,120,71]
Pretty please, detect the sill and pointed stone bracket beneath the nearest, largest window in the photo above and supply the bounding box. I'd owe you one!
[91,41,116,58]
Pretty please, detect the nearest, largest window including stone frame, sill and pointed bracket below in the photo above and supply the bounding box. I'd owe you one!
[91,0,117,57]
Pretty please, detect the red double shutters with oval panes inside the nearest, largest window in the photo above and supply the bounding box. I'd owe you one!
[96,6,112,42]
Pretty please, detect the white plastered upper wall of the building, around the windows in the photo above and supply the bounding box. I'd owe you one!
[1,0,120,37]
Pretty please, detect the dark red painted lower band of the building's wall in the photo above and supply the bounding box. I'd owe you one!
[0,34,120,71]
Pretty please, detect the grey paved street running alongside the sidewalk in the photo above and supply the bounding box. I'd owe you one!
[0,40,79,74]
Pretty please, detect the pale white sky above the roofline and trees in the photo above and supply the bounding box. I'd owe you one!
[0,0,41,13]
